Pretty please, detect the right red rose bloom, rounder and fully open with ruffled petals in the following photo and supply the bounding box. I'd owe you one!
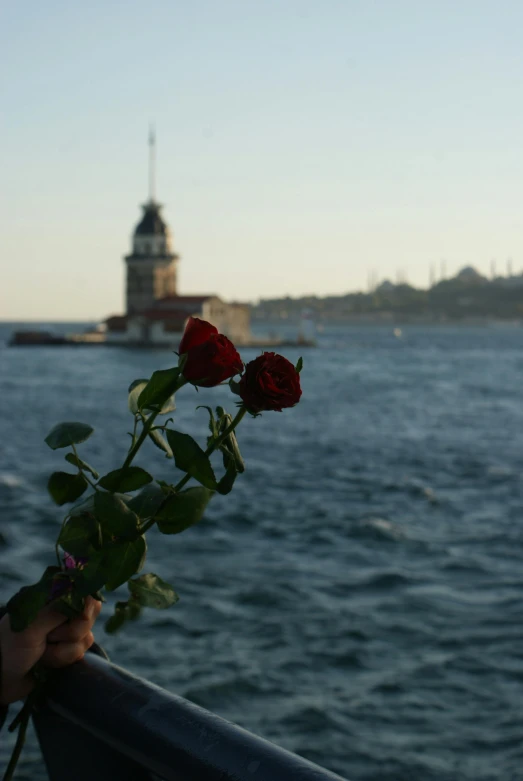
[238,353,301,412]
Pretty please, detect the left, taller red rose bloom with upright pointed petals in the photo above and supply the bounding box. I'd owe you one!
[179,317,243,388]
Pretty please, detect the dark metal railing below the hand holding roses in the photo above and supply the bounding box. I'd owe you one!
[34,654,350,781]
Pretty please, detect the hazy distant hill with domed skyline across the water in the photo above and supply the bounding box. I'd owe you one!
[251,266,523,322]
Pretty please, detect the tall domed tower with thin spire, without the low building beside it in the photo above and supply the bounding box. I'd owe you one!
[125,127,179,314]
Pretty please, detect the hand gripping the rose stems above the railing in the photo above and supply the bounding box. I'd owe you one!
[0,597,102,705]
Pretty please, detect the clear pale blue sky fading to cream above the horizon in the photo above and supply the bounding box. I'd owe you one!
[0,0,523,320]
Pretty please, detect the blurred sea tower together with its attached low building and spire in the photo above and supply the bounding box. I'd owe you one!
[106,134,251,347]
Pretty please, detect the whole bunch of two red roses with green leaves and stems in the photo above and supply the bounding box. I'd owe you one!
[4,317,302,781]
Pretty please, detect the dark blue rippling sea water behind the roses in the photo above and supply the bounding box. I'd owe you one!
[0,320,523,781]
